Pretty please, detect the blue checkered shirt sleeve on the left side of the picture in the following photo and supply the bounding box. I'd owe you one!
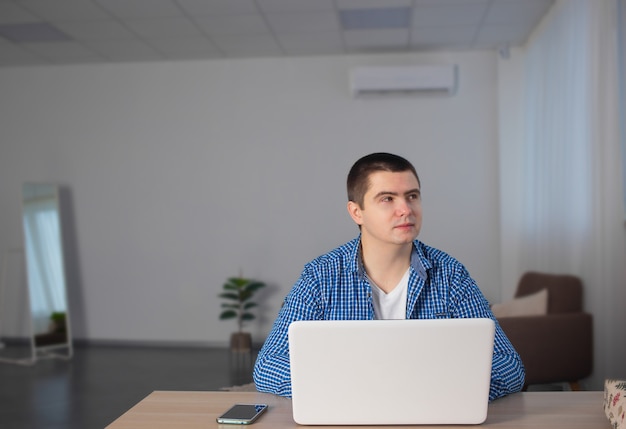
[253,268,321,397]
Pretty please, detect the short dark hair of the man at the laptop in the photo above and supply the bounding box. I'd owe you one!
[347,152,421,208]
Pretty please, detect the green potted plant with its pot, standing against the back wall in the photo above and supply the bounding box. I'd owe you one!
[219,276,265,351]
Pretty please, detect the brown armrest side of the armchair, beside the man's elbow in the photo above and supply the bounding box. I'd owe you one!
[498,313,593,385]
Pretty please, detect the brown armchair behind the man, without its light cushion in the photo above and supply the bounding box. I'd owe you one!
[498,272,593,390]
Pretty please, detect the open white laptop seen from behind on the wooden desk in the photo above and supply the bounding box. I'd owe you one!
[289,319,495,425]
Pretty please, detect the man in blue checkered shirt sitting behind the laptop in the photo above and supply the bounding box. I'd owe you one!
[254,153,524,400]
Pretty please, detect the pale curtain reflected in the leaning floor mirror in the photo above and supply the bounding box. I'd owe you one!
[24,198,66,333]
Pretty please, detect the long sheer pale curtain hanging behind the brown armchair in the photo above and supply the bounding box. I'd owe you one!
[500,0,626,389]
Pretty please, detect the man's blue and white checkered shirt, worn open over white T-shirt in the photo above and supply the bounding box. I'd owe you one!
[254,238,525,401]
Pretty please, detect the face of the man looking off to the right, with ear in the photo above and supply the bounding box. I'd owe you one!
[348,171,422,244]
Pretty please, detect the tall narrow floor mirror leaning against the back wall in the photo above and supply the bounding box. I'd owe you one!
[22,183,73,362]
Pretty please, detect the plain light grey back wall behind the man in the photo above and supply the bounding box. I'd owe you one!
[0,52,501,344]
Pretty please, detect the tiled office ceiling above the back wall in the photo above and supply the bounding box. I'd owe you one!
[0,0,554,67]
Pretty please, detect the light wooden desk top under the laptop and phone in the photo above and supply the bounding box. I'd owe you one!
[107,391,610,429]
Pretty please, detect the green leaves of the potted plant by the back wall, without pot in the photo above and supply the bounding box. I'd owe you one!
[220,277,265,332]
